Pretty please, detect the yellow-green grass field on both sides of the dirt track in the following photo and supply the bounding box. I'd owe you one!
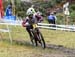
[0,25,75,57]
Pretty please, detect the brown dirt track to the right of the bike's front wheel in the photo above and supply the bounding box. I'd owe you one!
[47,44,75,57]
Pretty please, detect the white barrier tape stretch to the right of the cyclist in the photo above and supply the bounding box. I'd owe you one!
[38,23,75,31]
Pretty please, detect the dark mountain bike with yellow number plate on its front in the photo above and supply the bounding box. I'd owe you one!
[30,24,46,48]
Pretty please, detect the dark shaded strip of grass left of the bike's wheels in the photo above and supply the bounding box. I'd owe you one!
[1,39,33,47]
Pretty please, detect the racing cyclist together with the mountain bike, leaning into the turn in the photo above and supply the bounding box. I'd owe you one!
[22,5,45,48]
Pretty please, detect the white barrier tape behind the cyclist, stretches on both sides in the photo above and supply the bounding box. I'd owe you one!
[0,22,75,31]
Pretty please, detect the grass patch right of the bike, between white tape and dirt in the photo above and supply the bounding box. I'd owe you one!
[41,30,75,48]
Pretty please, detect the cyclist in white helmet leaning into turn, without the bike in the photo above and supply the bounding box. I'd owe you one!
[22,5,41,38]
